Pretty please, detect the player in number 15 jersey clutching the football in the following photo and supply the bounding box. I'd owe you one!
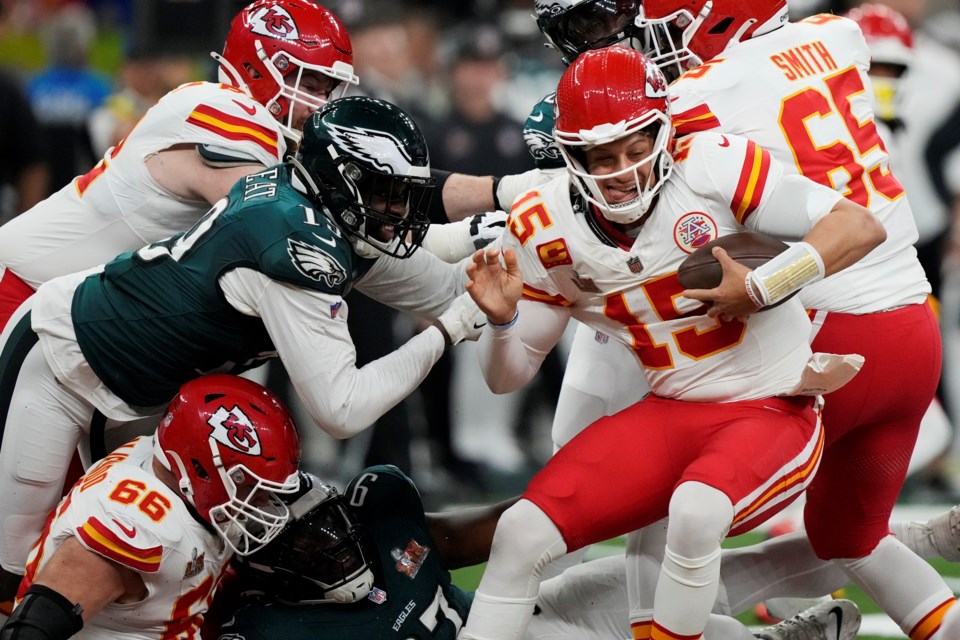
[460,46,885,640]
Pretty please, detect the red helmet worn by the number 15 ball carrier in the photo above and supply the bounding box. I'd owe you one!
[554,45,673,224]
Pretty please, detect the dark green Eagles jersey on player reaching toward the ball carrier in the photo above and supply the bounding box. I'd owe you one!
[72,165,374,407]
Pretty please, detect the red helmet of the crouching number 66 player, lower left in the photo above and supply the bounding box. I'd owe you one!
[155,374,300,555]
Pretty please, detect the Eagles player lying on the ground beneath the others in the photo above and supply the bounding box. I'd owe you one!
[212,466,860,640]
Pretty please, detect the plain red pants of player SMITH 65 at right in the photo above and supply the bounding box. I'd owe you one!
[804,304,943,559]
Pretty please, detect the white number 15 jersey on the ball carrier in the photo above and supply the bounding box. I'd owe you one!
[503,133,832,401]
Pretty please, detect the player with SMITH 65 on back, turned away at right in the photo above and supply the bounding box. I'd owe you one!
[635,0,954,640]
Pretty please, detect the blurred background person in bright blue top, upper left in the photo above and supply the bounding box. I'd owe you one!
[27,4,111,190]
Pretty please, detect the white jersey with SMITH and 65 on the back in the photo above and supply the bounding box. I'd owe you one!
[670,14,930,313]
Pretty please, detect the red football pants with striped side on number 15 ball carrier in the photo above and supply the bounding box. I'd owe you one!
[523,395,823,551]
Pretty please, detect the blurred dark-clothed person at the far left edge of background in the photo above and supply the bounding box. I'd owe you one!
[0,73,49,223]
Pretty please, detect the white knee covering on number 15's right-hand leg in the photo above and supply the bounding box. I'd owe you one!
[667,482,733,558]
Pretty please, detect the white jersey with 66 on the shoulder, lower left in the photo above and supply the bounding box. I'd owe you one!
[25,437,231,640]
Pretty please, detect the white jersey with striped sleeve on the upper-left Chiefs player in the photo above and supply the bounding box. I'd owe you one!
[0,82,286,289]
